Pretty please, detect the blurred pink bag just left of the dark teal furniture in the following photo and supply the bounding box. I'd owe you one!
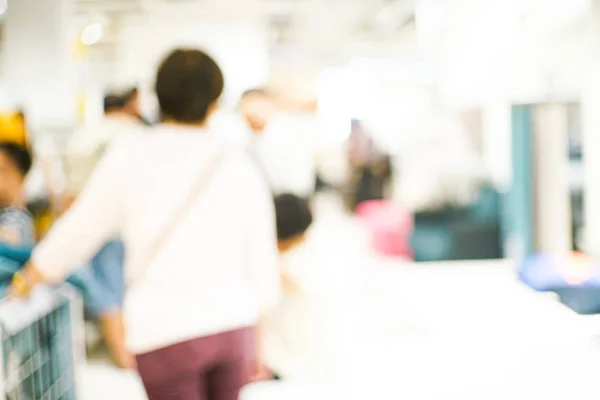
[356,200,414,259]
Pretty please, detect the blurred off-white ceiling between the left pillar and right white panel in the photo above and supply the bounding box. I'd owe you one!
[75,0,416,53]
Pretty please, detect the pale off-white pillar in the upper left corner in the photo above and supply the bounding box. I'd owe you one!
[2,0,78,125]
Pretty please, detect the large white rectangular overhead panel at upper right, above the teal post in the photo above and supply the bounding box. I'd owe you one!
[439,0,594,105]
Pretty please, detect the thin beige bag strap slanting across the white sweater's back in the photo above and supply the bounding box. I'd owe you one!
[128,151,227,285]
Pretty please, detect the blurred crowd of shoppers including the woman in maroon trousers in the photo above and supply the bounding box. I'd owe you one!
[0,38,488,400]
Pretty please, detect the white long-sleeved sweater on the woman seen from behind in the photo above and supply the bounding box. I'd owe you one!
[33,125,280,354]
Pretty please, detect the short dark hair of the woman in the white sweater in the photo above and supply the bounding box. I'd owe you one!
[156,49,224,123]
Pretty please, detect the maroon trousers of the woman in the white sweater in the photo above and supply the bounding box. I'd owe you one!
[137,328,256,400]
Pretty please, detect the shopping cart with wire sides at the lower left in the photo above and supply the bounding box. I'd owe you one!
[0,286,85,400]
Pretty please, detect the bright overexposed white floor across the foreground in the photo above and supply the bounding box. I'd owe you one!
[82,193,600,400]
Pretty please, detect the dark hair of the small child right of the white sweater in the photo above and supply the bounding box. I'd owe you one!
[275,193,313,240]
